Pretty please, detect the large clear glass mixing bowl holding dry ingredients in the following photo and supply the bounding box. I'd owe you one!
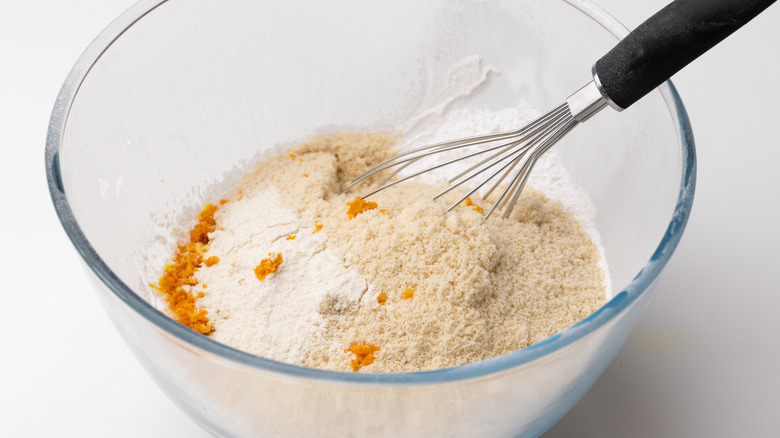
[46,0,695,437]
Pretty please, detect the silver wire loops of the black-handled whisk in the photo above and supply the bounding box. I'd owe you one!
[344,103,578,219]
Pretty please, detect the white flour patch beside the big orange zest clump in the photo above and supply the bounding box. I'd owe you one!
[196,187,367,363]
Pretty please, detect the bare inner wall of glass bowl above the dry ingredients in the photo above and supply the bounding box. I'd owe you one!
[59,0,682,370]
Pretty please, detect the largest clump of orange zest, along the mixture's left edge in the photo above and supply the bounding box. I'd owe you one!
[149,204,219,335]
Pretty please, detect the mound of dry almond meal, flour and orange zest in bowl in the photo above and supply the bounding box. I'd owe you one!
[149,133,606,372]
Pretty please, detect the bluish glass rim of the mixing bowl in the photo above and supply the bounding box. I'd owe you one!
[45,0,696,386]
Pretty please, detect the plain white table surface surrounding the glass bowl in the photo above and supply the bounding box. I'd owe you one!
[0,0,780,438]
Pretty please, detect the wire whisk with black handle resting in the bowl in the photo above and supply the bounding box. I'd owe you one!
[345,0,774,218]
